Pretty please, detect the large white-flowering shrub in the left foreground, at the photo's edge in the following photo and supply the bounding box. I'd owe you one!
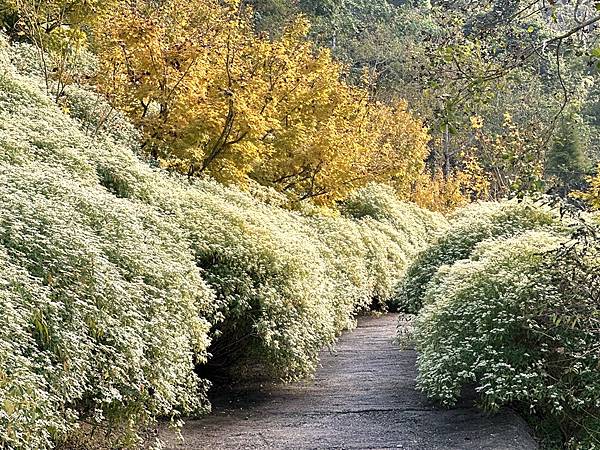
[0,51,215,449]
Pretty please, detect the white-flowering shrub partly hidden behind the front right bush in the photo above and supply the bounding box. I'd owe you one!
[392,199,563,314]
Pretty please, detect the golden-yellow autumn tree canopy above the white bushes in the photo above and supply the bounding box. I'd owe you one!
[96,0,428,203]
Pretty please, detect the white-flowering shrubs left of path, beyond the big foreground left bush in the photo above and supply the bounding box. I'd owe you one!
[111,177,440,379]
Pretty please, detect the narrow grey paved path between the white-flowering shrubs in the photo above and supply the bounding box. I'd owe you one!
[167,314,536,450]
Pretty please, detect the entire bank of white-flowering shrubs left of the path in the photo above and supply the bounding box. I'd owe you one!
[0,42,444,449]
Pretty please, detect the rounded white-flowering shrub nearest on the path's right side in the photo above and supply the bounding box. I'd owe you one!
[413,231,600,449]
